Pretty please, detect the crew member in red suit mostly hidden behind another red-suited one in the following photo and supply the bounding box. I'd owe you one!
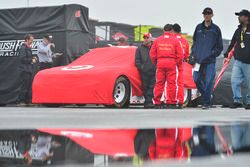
[173,24,189,108]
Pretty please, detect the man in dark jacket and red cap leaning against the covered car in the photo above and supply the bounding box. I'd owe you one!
[135,33,155,108]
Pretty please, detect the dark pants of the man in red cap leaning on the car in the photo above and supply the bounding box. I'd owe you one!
[141,72,155,104]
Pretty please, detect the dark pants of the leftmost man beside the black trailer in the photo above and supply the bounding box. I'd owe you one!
[19,72,32,103]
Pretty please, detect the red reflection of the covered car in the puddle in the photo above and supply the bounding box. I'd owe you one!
[38,128,137,156]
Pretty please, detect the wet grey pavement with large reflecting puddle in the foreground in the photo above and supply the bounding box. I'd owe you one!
[0,106,250,166]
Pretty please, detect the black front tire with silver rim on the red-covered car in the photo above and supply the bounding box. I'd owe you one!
[105,76,131,108]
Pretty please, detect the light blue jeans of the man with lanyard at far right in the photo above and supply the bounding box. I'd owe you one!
[231,60,250,104]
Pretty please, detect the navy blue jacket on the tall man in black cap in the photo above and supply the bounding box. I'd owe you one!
[191,22,223,64]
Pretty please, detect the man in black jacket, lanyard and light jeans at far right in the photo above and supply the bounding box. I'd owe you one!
[225,10,250,109]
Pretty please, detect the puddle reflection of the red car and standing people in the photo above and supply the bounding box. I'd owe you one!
[0,123,250,166]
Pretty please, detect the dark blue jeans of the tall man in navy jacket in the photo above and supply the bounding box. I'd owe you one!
[193,63,215,105]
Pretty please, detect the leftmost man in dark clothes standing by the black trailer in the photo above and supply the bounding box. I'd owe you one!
[19,34,37,105]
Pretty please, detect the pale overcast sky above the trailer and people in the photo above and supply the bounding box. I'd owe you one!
[0,0,250,39]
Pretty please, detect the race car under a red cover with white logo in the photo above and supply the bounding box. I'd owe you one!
[32,47,195,108]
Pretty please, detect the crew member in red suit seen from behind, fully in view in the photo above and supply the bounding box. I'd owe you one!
[150,24,183,108]
